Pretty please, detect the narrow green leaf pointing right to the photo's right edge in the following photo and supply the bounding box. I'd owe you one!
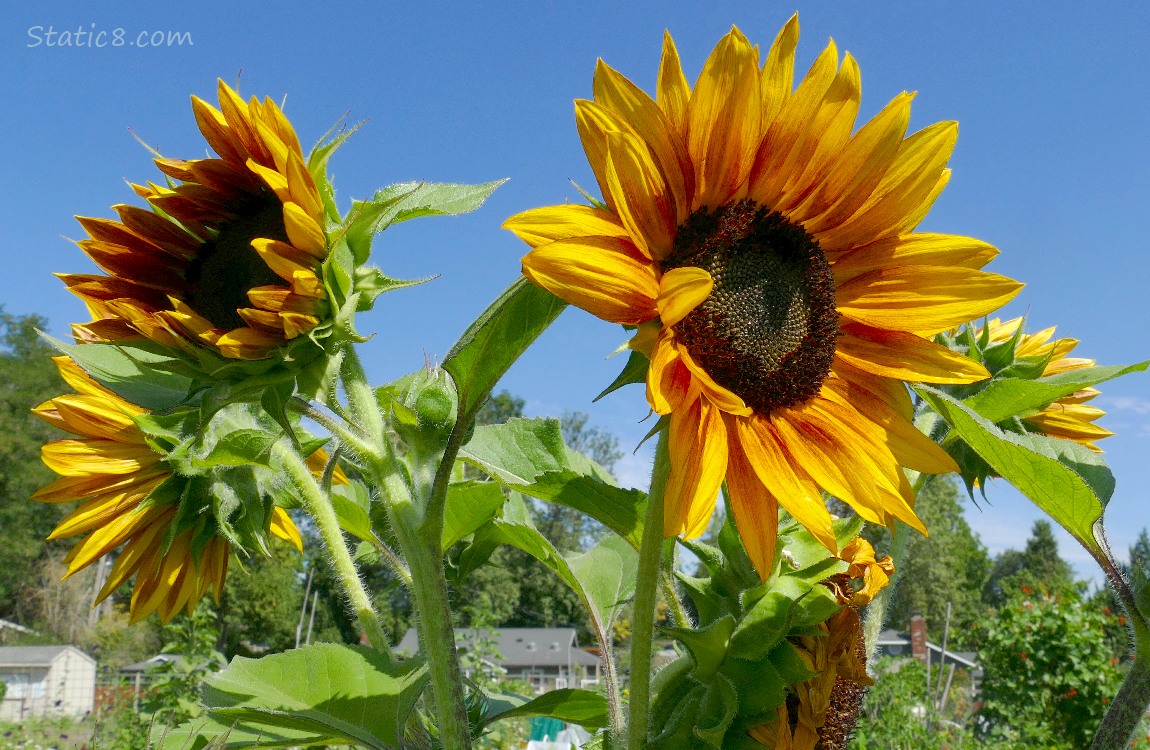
[963,361,1150,422]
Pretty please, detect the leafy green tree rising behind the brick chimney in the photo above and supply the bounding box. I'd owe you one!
[887,477,990,648]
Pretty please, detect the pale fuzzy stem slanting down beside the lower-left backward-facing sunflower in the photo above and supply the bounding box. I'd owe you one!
[276,442,391,653]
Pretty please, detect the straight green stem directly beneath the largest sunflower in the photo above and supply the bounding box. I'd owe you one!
[627,429,670,750]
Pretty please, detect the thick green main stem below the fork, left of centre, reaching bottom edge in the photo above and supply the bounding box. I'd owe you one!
[376,466,472,750]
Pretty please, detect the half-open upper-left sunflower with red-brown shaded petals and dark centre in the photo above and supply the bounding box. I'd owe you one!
[60,81,330,360]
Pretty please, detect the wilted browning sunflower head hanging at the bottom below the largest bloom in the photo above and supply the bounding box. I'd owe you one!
[750,536,895,750]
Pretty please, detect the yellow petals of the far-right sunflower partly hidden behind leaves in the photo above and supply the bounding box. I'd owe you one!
[976,317,1113,453]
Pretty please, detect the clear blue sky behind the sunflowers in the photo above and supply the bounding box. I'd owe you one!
[0,0,1150,576]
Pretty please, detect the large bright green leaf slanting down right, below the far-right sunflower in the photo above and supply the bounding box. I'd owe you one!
[914,385,1114,554]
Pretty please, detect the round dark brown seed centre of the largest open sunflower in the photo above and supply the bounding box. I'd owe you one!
[662,200,838,413]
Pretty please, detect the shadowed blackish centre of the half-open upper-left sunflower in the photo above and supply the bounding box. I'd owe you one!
[186,193,288,330]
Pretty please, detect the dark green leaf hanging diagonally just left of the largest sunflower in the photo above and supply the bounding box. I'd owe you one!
[443,276,567,423]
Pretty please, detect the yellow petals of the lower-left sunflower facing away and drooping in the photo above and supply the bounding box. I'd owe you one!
[32,357,319,622]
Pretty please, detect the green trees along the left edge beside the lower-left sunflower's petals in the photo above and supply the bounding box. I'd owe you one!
[0,307,70,621]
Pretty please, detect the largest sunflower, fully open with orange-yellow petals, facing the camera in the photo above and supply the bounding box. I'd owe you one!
[505,18,1021,576]
